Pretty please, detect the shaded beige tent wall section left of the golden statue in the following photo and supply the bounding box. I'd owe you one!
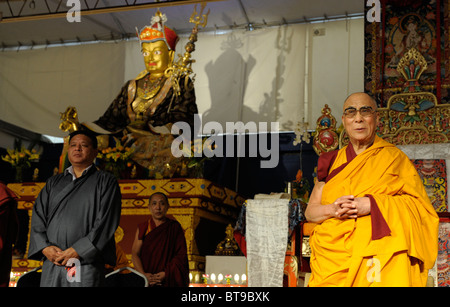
[0,44,125,136]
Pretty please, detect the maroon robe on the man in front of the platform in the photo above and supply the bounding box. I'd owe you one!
[138,218,189,287]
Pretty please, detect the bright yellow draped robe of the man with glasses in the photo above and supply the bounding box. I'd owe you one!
[308,136,439,287]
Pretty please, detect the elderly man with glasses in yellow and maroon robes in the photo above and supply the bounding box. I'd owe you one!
[305,93,439,287]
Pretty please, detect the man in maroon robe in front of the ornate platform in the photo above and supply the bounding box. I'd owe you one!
[131,192,189,287]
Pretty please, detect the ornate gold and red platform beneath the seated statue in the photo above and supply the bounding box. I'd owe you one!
[8,178,245,274]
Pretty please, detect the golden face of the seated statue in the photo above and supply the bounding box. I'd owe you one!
[142,41,173,74]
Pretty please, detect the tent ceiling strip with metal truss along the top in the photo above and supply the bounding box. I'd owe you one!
[0,0,365,50]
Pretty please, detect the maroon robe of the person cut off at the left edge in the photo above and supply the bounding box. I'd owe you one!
[0,182,18,287]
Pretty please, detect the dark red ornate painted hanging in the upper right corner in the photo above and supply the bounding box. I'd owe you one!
[364,0,450,108]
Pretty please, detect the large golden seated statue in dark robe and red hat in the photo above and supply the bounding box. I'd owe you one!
[67,11,198,178]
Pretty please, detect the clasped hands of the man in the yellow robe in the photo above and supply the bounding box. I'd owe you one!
[330,195,370,219]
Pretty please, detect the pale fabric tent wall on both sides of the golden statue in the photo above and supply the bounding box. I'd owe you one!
[0,19,364,136]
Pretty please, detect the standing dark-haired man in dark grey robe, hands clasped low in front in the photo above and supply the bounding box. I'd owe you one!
[28,131,121,287]
